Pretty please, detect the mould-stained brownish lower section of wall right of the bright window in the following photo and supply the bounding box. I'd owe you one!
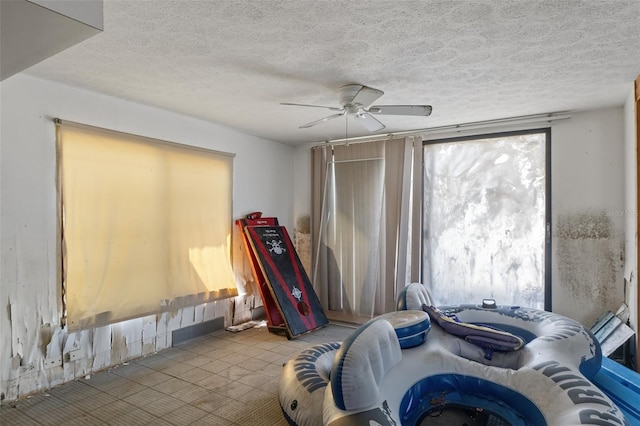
[554,211,624,324]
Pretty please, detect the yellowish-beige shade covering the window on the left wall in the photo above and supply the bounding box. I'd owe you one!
[57,122,237,330]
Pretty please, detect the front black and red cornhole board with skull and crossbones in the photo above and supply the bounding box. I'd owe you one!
[245,226,329,338]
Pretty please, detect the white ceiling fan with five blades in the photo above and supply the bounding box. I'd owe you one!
[280,84,432,132]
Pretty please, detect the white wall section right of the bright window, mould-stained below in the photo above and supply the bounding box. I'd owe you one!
[551,108,625,326]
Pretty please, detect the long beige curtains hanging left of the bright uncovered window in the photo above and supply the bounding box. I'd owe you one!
[312,139,412,322]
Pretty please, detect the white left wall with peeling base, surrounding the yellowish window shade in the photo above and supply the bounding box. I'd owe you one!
[0,74,294,400]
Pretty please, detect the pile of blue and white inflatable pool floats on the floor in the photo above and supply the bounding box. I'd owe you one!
[279,284,629,426]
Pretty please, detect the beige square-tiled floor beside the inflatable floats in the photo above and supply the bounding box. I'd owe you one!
[0,324,354,426]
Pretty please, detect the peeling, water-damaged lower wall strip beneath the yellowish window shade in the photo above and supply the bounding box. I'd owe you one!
[0,296,245,401]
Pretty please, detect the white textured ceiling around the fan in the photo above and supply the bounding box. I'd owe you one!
[27,0,640,144]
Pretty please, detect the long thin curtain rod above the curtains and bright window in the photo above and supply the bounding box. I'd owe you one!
[314,112,571,146]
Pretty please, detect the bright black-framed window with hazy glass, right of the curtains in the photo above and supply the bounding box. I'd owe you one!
[421,130,551,309]
